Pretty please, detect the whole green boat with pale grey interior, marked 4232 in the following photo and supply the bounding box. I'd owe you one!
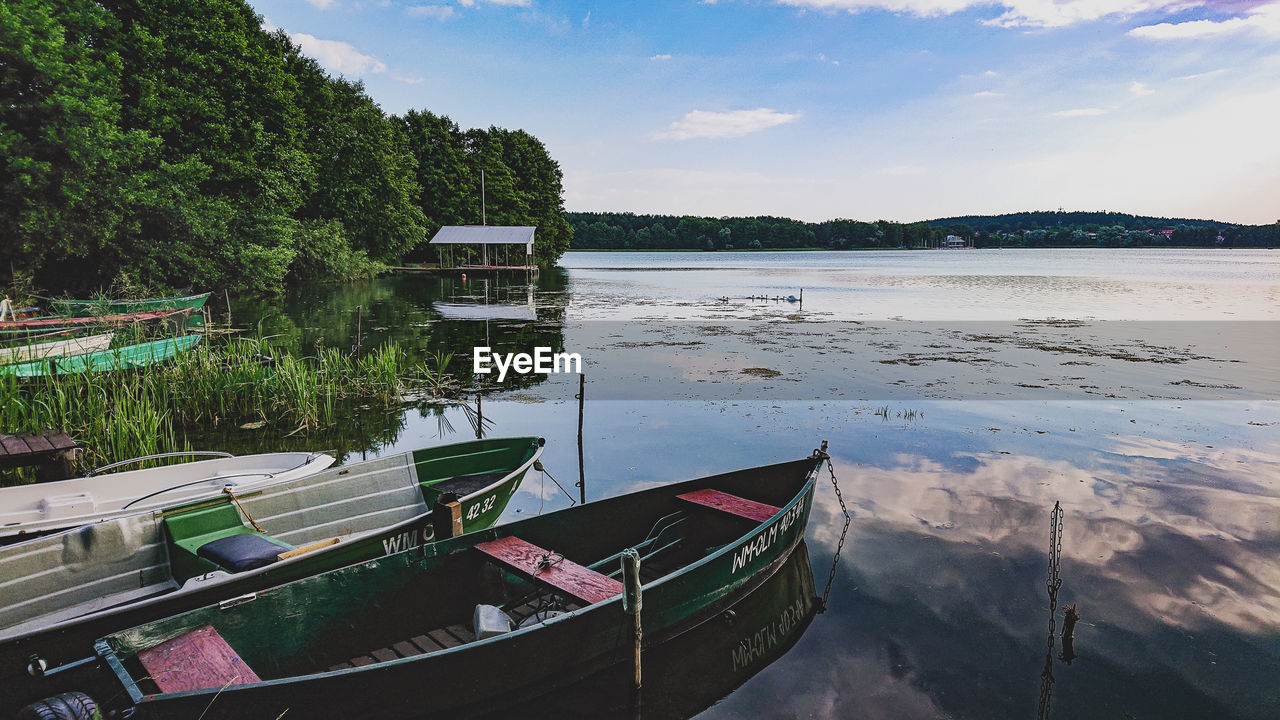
[0,437,544,717]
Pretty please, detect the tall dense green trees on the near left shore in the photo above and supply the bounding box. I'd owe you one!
[0,0,571,292]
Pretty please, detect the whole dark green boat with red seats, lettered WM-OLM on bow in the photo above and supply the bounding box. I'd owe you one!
[20,451,827,719]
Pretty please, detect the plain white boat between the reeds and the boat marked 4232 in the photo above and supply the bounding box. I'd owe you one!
[0,452,334,541]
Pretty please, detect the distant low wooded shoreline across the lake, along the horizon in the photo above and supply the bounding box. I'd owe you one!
[568,211,1280,250]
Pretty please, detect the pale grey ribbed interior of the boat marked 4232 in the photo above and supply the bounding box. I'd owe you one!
[0,437,540,632]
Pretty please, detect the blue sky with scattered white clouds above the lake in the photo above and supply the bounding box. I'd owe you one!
[250,0,1280,223]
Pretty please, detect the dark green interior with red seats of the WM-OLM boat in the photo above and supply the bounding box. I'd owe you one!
[99,464,812,693]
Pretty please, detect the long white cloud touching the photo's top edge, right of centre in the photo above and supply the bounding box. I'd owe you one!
[776,0,1261,27]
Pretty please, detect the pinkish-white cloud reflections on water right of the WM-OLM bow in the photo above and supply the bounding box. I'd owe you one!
[812,441,1280,634]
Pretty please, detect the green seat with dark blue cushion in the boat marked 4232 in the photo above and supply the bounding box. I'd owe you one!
[164,502,293,573]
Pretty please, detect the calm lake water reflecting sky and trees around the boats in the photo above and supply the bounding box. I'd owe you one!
[225,250,1280,720]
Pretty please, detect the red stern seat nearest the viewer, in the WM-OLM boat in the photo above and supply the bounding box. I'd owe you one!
[138,625,261,693]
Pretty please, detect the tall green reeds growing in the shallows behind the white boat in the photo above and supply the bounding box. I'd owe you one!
[0,338,416,464]
